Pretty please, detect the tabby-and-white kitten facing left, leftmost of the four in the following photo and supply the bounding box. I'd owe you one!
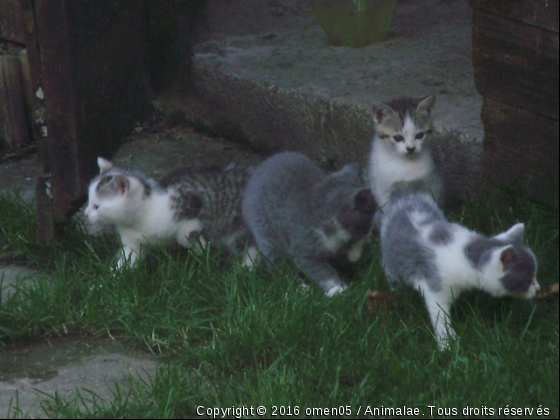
[85,158,255,268]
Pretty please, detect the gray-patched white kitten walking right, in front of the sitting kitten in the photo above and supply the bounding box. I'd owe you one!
[381,192,540,348]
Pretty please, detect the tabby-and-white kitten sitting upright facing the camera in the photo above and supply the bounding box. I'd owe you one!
[369,95,443,207]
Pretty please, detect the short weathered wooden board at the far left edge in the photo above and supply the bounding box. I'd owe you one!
[0,55,31,149]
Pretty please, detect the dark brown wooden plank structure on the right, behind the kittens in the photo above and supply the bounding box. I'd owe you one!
[470,0,559,195]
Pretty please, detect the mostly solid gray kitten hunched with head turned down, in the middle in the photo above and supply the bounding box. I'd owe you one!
[242,153,377,296]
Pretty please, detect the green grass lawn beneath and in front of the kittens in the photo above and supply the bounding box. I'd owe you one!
[0,191,559,418]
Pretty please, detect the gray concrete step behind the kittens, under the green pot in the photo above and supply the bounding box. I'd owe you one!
[156,0,483,205]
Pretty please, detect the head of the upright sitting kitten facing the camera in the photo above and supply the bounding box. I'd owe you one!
[373,95,436,156]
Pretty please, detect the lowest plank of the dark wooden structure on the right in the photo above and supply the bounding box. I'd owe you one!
[481,99,559,195]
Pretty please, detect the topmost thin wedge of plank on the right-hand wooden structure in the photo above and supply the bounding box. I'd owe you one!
[470,0,560,32]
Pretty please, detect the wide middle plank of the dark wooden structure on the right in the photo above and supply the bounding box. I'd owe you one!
[473,9,559,120]
